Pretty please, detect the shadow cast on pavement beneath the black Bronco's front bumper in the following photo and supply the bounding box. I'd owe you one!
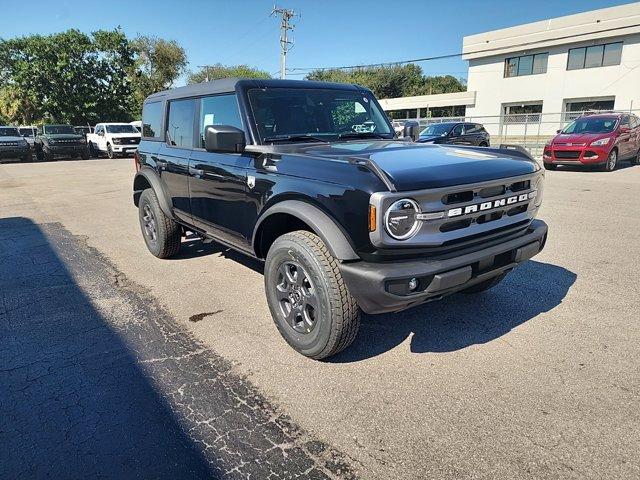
[329,260,577,363]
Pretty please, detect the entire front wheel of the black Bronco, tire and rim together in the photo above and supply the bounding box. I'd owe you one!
[264,230,360,360]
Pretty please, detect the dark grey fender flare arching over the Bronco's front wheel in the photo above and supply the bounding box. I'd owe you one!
[252,200,360,260]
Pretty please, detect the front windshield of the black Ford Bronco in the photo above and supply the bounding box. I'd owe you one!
[249,88,395,142]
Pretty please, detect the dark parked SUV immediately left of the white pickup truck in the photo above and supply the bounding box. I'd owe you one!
[34,125,89,160]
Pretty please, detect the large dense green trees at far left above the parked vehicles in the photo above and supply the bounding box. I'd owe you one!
[0,29,133,124]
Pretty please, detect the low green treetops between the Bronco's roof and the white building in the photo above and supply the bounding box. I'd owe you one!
[306,64,466,98]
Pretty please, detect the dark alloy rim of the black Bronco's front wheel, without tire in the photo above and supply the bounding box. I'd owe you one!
[276,261,318,334]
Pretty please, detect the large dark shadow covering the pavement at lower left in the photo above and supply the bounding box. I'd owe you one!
[0,218,214,479]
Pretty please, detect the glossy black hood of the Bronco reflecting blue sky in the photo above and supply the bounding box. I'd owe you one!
[298,141,540,191]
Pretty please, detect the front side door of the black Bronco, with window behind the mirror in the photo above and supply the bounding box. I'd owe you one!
[189,94,253,250]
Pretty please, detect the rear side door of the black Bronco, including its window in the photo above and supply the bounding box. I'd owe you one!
[156,98,196,223]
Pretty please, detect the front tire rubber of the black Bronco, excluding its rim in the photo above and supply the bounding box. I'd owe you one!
[264,230,360,360]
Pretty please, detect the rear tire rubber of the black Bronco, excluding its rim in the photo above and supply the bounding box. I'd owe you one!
[138,188,182,258]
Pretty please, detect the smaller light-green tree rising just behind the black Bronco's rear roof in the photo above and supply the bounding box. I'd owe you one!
[131,36,187,116]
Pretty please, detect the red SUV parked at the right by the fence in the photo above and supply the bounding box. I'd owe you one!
[542,113,640,172]
